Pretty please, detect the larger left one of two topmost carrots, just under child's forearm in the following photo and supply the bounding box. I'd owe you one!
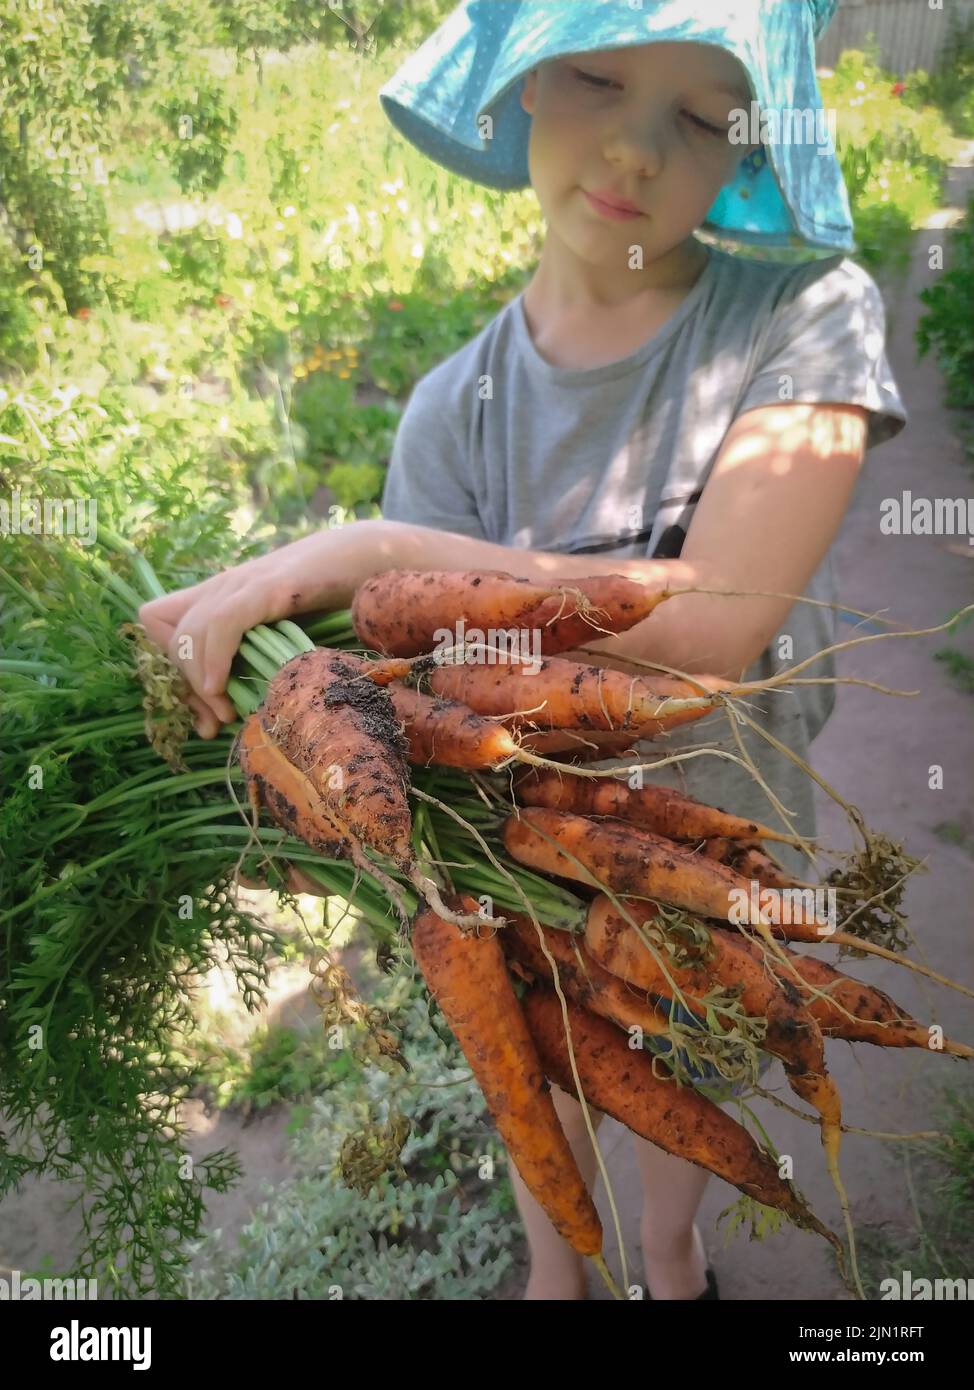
[352,570,557,656]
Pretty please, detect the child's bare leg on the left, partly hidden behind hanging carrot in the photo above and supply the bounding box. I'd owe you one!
[510,1086,602,1300]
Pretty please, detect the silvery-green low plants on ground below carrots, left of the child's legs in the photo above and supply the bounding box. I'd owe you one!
[180,995,518,1301]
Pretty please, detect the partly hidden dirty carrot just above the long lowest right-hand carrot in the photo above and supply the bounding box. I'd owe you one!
[500,912,670,1037]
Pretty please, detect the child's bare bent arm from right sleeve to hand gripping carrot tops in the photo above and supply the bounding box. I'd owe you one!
[139,404,866,737]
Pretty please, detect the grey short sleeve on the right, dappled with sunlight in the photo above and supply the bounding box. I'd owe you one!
[736,257,907,449]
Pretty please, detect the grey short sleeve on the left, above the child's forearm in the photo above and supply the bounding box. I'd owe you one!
[381,373,486,541]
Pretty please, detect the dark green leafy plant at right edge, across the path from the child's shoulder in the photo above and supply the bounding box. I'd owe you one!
[916,196,974,409]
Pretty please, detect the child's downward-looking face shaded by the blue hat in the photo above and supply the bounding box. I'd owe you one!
[521,43,753,264]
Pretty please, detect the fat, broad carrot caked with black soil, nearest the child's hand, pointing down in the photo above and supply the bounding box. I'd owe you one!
[257,648,413,872]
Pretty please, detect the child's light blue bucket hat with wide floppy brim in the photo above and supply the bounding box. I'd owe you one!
[379,0,856,252]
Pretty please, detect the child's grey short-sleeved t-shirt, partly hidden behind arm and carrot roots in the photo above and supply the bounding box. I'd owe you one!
[382,239,906,869]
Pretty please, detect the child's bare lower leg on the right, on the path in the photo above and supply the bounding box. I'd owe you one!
[632,1134,710,1300]
